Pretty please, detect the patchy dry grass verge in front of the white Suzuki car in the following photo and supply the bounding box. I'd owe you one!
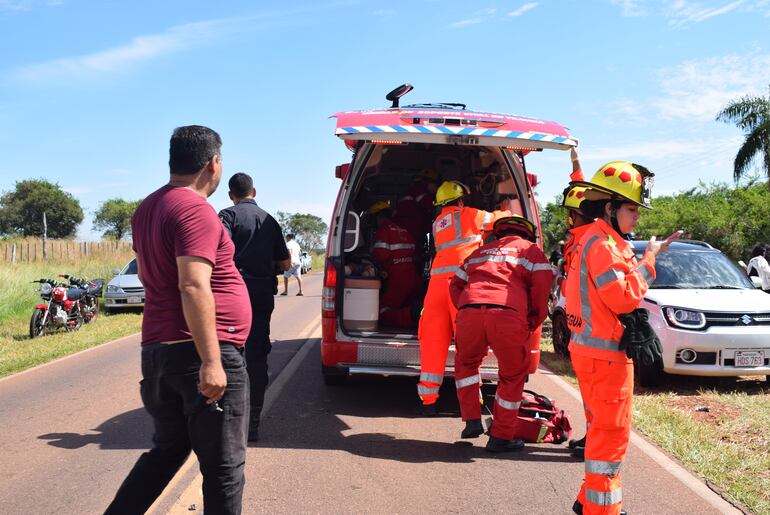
[540,320,770,514]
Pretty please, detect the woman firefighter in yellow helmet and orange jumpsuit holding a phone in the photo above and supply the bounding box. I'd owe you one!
[566,161,681,515]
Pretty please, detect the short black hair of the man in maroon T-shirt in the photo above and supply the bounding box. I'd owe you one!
[168,125,222,175]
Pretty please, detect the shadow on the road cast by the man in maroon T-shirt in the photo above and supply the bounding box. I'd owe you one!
[38,408,152,449]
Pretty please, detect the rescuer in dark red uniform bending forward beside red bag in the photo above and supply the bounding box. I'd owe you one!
[449,215,553,452]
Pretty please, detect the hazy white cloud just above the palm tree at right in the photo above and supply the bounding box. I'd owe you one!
[650,55,770,121]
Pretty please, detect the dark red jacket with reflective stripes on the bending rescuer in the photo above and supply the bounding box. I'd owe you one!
[449,235,553,330]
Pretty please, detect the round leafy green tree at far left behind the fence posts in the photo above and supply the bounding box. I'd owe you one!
[0,179,83,238]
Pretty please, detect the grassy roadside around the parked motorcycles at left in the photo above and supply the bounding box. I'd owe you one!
[0,250,141,377]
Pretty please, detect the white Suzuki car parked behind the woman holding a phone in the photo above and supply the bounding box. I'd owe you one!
[552,241,770,386]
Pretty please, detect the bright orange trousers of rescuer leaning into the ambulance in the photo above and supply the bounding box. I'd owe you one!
[417,274,457,405]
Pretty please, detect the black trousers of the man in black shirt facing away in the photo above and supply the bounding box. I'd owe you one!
[243,277,275,428]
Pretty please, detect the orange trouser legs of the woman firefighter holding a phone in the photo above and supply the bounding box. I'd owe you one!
[571,352,634,515]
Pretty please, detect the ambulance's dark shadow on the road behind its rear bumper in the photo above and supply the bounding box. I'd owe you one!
[254,371,574,463]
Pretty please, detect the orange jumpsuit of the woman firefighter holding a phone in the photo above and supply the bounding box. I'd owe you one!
[567,219,655,515]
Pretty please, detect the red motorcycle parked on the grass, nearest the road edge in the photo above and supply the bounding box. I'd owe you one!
[29,279,84,338]
